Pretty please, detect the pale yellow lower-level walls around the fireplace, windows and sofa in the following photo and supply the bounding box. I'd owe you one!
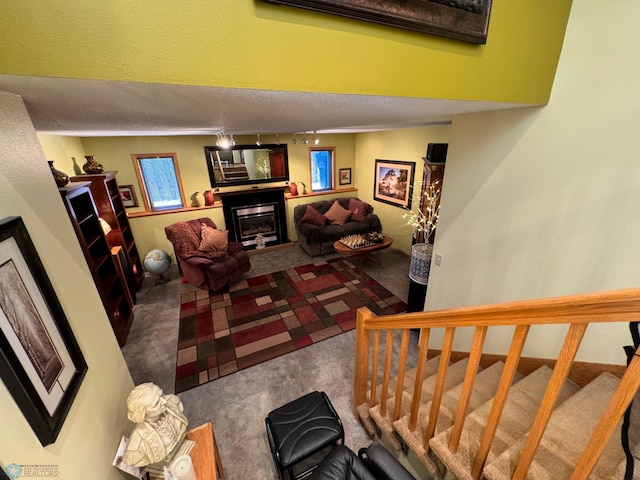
[39,126,450,255]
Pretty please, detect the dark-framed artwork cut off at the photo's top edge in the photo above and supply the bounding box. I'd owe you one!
[262,0,492,44]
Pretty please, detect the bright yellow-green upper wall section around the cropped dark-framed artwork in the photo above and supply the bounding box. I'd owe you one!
[0,0,571,103]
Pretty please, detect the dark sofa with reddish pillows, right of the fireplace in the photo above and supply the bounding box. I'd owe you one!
[293,197,382,257]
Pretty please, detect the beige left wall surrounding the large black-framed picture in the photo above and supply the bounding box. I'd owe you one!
[0,92,133,479]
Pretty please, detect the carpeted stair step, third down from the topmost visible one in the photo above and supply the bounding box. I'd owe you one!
[393,361,522,475]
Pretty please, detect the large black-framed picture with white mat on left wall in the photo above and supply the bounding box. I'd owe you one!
[0,217,87,446]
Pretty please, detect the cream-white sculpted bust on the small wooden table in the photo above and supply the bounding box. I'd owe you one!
[123,383,187,467]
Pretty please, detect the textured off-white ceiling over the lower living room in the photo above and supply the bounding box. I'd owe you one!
[0,75,525,136]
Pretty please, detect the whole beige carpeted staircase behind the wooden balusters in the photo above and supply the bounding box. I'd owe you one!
[356,357,626,480]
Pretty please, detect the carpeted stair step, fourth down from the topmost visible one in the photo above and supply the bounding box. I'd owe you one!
[369,358,469,450]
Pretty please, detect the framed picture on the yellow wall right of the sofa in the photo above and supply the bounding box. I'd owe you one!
[373,159,416,209]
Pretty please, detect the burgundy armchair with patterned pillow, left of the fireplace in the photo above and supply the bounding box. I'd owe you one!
[165,218,251,291]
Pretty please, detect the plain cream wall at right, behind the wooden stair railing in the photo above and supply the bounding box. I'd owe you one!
[427,0,640,363]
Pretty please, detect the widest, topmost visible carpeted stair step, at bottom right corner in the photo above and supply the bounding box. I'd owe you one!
[484,373,626,480]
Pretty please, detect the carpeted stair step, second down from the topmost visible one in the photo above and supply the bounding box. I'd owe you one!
[429,366,579,480]
